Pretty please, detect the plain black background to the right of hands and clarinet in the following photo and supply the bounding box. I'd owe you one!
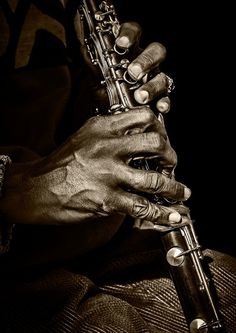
[114,0,236,256]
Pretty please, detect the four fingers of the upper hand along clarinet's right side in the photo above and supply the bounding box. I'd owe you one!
[115,22,171,113]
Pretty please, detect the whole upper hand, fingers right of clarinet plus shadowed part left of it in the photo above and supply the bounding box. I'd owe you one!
[80,22,174,113]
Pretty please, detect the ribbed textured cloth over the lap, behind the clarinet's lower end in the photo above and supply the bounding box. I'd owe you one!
[0,236,236,333]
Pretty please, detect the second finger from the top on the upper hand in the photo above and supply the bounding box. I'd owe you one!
[128,43,166,80]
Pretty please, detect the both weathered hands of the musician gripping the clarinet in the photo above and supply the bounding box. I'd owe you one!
[1,23,190,228]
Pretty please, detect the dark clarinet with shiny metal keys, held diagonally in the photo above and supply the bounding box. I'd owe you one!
[78,0,225,333]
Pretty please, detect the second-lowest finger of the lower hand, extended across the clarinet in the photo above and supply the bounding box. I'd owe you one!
[118,166,191,201]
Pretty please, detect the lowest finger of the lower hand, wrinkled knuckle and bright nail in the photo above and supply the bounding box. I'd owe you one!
[115,192,181,224]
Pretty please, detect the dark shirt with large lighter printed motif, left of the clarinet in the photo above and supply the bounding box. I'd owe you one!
[0,0,85,154]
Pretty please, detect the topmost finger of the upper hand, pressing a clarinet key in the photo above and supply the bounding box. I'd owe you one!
[115,22,142,49]
